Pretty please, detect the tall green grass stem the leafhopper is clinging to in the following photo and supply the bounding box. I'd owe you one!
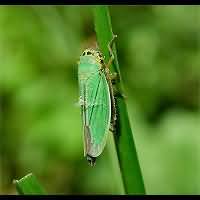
[93,6,145,194]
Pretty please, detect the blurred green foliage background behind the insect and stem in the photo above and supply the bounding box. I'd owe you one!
[0,6,200,194]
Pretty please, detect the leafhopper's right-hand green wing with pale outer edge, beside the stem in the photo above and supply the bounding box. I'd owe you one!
[87,73,111,157]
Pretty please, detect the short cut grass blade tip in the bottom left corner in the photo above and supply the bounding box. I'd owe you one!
[13,173,45,195]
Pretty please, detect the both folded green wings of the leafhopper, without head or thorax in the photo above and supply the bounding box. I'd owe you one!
[79,59,111,157]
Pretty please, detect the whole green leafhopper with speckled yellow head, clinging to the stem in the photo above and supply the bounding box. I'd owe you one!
[78,36,116,166]
